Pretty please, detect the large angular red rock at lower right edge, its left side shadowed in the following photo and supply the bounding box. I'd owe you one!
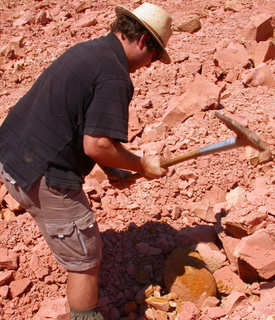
[234,225,275,282]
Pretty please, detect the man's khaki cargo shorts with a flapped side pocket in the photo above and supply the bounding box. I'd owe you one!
[0,163,102,271]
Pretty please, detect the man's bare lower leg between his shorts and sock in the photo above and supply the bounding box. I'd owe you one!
[67,264,99,310]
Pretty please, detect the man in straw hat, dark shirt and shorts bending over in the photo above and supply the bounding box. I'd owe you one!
[0,3,172,320]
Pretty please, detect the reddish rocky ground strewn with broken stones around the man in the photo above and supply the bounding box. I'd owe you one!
[0,0,275,320]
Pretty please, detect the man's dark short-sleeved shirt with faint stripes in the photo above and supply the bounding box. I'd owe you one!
[0,33,133,189]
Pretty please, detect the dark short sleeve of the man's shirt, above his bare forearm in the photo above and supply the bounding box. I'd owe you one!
[84,78,133,142]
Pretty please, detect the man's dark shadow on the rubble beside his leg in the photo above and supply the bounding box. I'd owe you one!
[99,221,220,319]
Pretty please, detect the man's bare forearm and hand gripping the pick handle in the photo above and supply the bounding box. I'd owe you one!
[83,135,167,179]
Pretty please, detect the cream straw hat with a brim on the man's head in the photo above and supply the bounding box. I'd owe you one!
[115,2,172,64]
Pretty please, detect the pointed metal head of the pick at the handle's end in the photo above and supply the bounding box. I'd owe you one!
[215,112,267,151]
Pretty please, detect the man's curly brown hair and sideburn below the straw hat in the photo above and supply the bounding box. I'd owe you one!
[110,14,163,53]
